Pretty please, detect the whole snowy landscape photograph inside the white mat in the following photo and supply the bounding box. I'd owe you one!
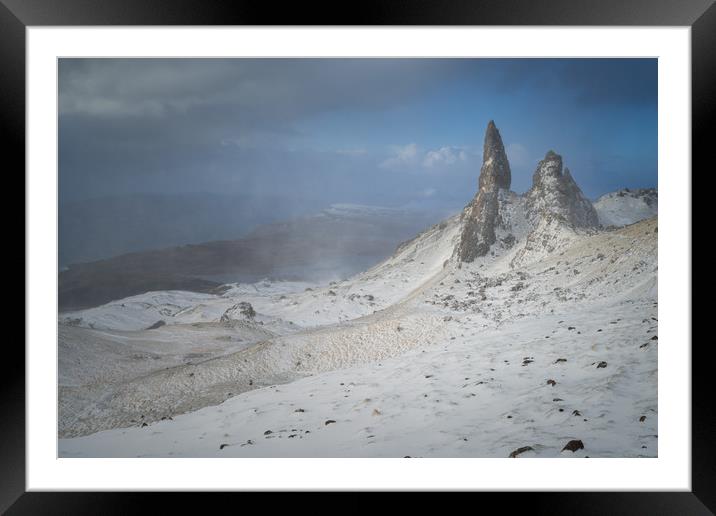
[58,58,656,459]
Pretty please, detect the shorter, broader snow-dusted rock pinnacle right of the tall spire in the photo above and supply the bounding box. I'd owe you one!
[525,150,599,228]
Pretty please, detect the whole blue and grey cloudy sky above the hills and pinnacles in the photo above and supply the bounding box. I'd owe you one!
[59,59,657,207]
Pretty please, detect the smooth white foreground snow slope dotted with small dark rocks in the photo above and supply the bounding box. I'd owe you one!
[59,302,658,457]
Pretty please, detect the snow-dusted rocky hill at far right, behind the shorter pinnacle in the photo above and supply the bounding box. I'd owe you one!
[594,188,659,226]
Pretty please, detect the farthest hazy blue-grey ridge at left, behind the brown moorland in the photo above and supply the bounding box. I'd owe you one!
[58,192,319,267]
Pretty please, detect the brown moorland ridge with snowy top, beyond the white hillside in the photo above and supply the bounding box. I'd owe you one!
[59,204,442,311]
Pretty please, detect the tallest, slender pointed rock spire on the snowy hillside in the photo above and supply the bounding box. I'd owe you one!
[456,120,511,262]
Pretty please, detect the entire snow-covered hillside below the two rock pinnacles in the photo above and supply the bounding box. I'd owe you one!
[59,212,658,457]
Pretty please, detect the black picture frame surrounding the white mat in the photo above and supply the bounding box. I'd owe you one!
[0,0,716,514]
